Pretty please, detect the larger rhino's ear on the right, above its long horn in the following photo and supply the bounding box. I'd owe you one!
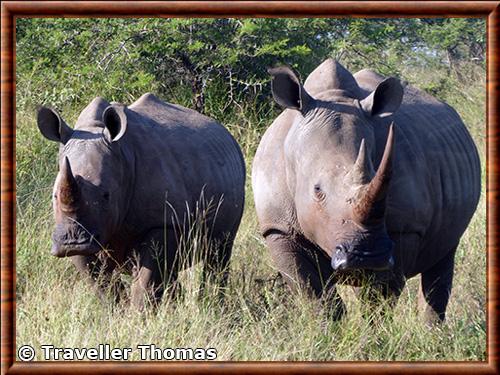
[360,77,403,117]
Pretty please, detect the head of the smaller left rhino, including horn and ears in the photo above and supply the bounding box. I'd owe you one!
[37,99,127,257]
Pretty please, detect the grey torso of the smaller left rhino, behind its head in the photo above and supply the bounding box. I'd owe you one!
[126,94,245,236]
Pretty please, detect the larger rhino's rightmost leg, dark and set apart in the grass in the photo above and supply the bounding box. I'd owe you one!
[419,247,457,325]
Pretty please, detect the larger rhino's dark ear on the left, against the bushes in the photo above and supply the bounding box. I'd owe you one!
[268,66,314,114]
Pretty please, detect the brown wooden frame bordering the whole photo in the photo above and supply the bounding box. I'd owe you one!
[1,1,500,374]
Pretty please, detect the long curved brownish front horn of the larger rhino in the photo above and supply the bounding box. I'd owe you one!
[354,124,394,223]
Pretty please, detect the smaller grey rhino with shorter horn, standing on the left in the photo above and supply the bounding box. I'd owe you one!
[38,93,245,308]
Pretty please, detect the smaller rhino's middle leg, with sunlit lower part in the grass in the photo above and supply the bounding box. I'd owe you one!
[130,229,178,310]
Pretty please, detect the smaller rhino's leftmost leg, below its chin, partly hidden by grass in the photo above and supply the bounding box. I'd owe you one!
[71,255,124,302]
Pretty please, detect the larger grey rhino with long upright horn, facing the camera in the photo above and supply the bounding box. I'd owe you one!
[252,59,481,323]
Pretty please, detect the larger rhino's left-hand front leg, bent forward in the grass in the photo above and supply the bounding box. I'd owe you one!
[266,233,345,319]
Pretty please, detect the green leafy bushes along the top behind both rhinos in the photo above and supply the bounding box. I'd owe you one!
[16,18,485,112]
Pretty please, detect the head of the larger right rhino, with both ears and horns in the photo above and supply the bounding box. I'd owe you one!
[269,67,403,272]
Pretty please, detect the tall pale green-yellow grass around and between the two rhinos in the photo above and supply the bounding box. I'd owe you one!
[16,67,486,361]
